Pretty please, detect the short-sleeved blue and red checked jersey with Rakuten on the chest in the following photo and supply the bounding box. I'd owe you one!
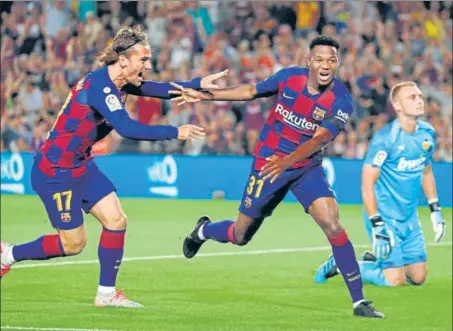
[254,67,353,170]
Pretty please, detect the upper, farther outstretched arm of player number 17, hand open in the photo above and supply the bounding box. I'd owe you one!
[123,70,228,99]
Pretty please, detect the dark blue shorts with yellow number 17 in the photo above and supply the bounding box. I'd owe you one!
[31,160,116,230]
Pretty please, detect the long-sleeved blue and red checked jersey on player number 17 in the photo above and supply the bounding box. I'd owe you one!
[35,67,200,177]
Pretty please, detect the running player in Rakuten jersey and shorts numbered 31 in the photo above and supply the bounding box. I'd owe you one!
[169,36,384,318]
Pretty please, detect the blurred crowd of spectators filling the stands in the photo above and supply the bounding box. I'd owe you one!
[1,0,453,161]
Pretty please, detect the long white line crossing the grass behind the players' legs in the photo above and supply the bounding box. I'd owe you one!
[13,241,452,269]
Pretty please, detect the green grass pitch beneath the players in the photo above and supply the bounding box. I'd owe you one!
[1,196,452,331]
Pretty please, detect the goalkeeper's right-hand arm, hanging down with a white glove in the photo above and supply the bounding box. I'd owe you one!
[422,163,445,242]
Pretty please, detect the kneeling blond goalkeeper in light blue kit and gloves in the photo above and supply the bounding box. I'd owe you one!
[315,82,445,286]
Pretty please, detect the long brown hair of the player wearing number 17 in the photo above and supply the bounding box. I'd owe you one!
[98,26,149,66]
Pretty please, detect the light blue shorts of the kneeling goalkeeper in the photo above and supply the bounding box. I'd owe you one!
[363,212,427,269]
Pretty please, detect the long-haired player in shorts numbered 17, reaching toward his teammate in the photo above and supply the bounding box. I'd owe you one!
[1,27,227,308]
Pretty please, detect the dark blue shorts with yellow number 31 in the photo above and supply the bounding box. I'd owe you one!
[239,164,335,219]
